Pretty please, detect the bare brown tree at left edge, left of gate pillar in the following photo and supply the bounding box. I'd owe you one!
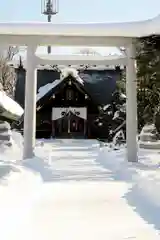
[0,46,19,98]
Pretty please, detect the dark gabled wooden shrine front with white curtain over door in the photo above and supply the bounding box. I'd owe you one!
[37,76,99,138]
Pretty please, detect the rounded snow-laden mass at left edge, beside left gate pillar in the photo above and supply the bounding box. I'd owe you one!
[0,91,24,120]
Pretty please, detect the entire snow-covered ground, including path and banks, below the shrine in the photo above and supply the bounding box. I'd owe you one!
[0,134,160,240]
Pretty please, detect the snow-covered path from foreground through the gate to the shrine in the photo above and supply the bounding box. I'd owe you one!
[0,140,159,240]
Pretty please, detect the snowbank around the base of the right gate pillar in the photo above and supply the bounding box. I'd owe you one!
[102,146,160,208]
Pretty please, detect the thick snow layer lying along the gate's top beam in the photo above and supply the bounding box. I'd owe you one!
[0,16,160,37]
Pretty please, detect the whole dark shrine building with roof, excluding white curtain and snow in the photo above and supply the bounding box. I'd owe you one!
[15,68,120,138]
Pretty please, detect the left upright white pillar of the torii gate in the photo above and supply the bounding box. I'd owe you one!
[23,46,37,159]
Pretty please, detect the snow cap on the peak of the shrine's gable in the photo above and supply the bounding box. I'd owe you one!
[60,67,84,84]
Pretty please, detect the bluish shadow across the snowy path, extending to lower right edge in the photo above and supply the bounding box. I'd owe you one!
[23,140,160,230]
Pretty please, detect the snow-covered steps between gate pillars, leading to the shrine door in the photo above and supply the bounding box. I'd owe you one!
[26,139,111,182]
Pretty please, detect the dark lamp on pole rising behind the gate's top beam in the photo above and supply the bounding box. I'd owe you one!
[41,0,59,54]
